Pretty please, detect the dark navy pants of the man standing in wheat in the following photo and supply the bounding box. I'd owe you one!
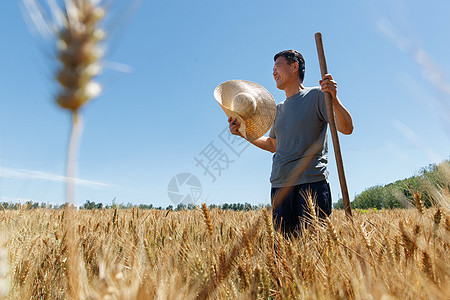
[271,180,331,235]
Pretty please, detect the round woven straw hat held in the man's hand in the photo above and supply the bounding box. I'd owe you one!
[214,80,277,141]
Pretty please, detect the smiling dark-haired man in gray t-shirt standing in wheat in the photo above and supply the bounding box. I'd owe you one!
[228,50,353,234]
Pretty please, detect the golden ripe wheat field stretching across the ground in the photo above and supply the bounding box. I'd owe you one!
[0,199,450,299]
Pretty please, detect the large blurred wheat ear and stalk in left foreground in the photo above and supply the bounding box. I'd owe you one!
[23,0,106,299]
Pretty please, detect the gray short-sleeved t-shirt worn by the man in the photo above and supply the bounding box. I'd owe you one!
[269,87,328,188]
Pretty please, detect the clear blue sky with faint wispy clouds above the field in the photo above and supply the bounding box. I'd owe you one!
[0,0,450,207]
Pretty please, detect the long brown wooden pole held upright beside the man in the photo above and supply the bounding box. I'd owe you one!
[314,32,352,218]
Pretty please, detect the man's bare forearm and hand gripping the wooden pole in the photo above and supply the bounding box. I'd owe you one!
[319,74,353,134]
